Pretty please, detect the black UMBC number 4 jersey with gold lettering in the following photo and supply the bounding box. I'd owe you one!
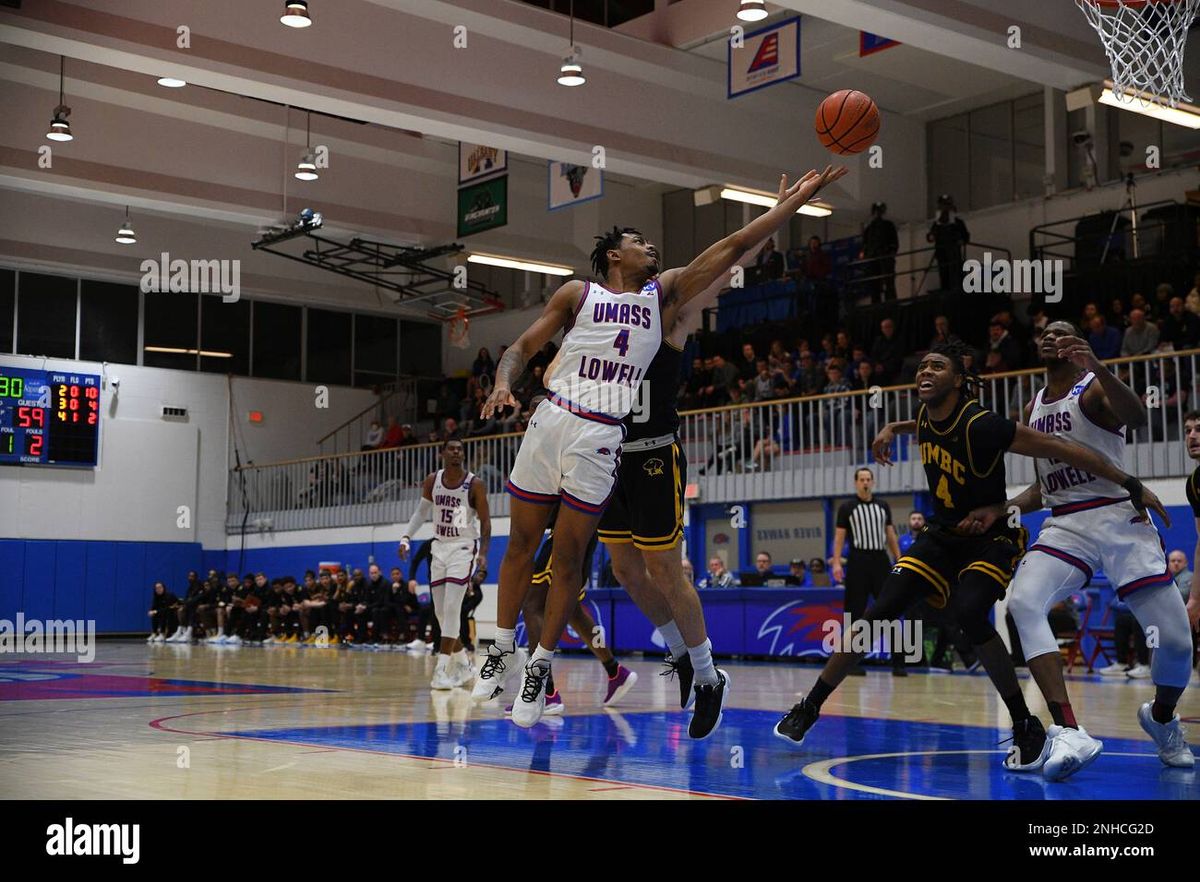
[917,398,1016,527]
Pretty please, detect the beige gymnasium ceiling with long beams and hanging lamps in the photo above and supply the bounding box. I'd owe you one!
[0,0,1104,316]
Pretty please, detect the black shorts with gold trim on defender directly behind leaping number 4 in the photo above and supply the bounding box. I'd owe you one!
[596,440,688,551]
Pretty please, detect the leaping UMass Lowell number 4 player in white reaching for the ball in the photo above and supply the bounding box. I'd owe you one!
[474,169,840,727]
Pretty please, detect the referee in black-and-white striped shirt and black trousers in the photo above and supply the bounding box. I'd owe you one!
[833,468,908,677]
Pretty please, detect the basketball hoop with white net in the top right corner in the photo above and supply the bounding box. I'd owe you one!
[1075,0,1200,107]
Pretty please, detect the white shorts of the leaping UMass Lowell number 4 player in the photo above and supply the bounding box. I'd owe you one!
[505,398,625,515]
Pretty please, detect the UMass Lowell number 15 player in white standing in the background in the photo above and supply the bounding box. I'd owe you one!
[400,440,492,689]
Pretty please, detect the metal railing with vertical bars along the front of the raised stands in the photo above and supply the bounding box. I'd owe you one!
[226,349,1200,533]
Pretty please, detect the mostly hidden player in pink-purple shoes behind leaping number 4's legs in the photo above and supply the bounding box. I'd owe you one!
[505,499,637,714]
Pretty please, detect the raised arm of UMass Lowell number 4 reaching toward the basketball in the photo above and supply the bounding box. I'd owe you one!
[659,166,846,316]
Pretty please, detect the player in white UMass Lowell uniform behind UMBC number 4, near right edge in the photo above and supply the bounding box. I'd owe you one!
[960,322,1194,781]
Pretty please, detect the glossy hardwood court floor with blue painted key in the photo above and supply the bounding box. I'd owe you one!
[0,642,1200,799]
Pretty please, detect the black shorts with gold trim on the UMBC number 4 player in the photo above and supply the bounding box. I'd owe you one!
[892,524,1028,608]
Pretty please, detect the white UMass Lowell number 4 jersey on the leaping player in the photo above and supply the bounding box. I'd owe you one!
[546,281,662,421]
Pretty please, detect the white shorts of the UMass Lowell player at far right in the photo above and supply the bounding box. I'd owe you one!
[1013,500,1171,599]
